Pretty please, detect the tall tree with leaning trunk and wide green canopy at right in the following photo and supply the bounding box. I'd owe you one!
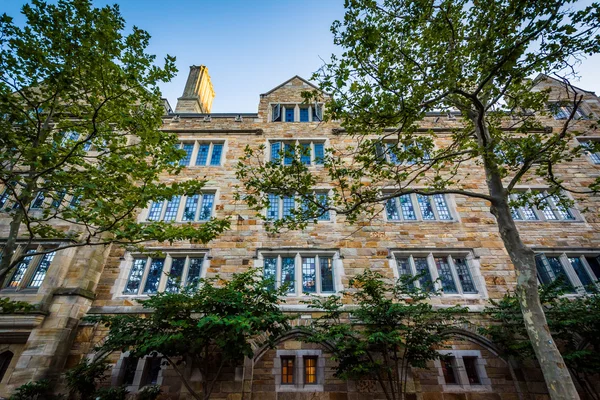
[238,0,600,399]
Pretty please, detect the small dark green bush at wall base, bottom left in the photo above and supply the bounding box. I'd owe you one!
[65,359,110,400]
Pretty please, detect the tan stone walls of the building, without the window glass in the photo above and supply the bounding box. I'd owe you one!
[0,67,600,400]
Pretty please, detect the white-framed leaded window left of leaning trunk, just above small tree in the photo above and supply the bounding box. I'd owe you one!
[393,251,481,295]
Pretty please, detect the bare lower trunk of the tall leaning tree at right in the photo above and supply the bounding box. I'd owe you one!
[486,178,579,400]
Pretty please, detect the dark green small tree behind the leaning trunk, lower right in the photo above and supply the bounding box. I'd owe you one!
[480,282,600,399]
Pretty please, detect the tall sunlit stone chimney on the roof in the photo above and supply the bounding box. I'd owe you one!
[175,65,215,114]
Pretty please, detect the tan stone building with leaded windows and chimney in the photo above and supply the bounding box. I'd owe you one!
[0,66,600,400]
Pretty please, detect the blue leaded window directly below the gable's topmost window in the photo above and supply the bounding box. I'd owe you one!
[269,140,325,165]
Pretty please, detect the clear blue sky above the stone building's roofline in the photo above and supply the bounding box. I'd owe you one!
[0,0,600,113]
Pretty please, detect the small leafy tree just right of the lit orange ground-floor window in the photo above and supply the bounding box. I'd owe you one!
[306,270,467,400]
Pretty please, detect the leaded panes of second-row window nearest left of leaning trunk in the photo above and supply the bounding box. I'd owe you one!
[395,252,478,294]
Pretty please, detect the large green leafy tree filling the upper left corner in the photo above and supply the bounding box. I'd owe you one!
[0,0,228,281]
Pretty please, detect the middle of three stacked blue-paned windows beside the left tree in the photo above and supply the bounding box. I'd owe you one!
[146,193,215,222]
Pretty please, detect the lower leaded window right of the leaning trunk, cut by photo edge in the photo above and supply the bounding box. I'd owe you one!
[535,251,600,294]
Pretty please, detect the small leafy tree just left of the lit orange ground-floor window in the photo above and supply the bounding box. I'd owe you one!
[92,269,290,400]
